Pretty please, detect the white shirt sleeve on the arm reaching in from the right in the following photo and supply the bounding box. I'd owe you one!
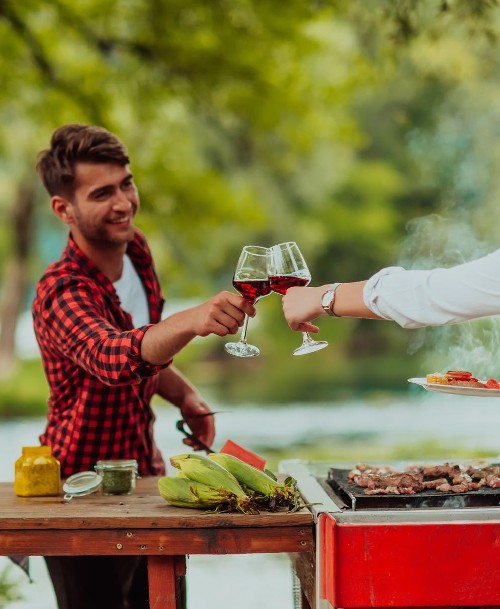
[363,249,500,328]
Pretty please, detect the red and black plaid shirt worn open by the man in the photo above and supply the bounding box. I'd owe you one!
[32,231,170,478]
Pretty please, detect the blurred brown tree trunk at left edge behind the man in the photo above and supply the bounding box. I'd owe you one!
[0,180,36,378]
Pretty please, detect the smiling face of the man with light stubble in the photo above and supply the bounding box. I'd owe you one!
[67,163,139,247]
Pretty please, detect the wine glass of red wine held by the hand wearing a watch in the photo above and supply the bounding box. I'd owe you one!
[268,241,328,355]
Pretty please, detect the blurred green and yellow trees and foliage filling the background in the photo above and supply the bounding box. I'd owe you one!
[0,0,500,416]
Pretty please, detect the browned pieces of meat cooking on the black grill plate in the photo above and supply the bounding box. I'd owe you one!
[347,463,500,495]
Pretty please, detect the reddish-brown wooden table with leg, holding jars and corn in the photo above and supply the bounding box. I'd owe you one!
[0,477,314,609]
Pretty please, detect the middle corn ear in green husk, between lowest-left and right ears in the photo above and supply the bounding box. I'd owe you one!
[170,453,248,500]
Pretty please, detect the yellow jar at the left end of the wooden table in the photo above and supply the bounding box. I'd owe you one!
[14,446,61,497]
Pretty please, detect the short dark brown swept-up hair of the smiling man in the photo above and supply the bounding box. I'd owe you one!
[36,124,130,198]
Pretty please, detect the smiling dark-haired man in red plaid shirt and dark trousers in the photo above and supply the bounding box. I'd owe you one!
[32,124,255,609]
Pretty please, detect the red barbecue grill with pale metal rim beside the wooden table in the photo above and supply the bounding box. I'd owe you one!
[280,457,500,609]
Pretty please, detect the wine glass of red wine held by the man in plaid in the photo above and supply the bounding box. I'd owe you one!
[224,245,271,357]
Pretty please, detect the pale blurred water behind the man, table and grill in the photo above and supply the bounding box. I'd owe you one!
[0,388,500,609]
